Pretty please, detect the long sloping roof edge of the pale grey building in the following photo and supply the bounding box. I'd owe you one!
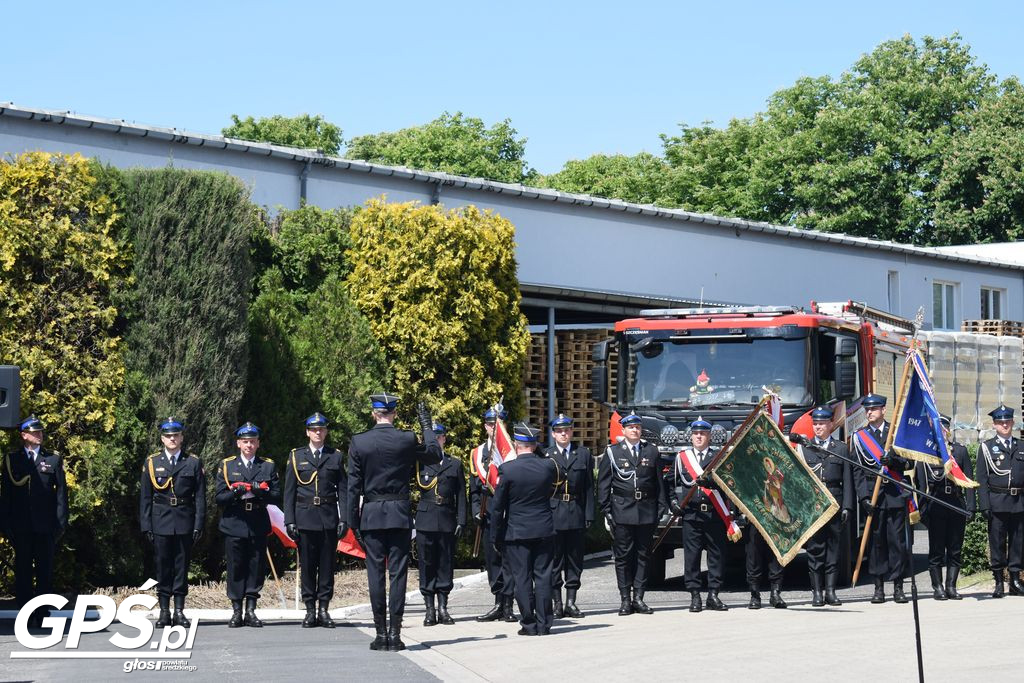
[0,102,1024,270]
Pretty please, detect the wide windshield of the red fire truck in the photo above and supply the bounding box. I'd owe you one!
[622,337,813,409]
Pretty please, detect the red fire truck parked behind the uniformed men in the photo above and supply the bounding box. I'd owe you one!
[591,301,915,583]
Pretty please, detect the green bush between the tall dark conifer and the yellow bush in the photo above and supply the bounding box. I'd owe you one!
[243,206,387,456]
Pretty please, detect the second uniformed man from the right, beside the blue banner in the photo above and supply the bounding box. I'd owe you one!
[916,415,975,600]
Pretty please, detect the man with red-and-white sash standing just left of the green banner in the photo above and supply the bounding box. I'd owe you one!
[672,418,728,612]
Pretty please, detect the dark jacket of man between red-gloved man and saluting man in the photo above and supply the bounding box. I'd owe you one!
[284,445,348,531]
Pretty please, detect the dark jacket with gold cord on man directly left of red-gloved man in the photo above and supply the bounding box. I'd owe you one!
[138,451,206,536]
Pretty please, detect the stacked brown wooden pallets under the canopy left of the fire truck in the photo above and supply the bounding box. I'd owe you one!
[523,330,614,450]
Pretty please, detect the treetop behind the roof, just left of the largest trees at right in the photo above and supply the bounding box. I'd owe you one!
[537,152,675,207]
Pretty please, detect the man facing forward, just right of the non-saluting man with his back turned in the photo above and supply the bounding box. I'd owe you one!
[545,413,594,618]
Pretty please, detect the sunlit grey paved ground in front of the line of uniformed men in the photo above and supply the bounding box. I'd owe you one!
[0,532,1024,681]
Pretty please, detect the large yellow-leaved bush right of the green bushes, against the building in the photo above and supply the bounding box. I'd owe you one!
[348,199,529,454]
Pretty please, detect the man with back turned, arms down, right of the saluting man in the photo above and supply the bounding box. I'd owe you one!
[490,422,558,636]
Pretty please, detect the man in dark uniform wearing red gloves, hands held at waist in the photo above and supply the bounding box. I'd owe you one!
[216,422,281,629]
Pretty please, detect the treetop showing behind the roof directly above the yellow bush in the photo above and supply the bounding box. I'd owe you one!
[345,112,537,182]
